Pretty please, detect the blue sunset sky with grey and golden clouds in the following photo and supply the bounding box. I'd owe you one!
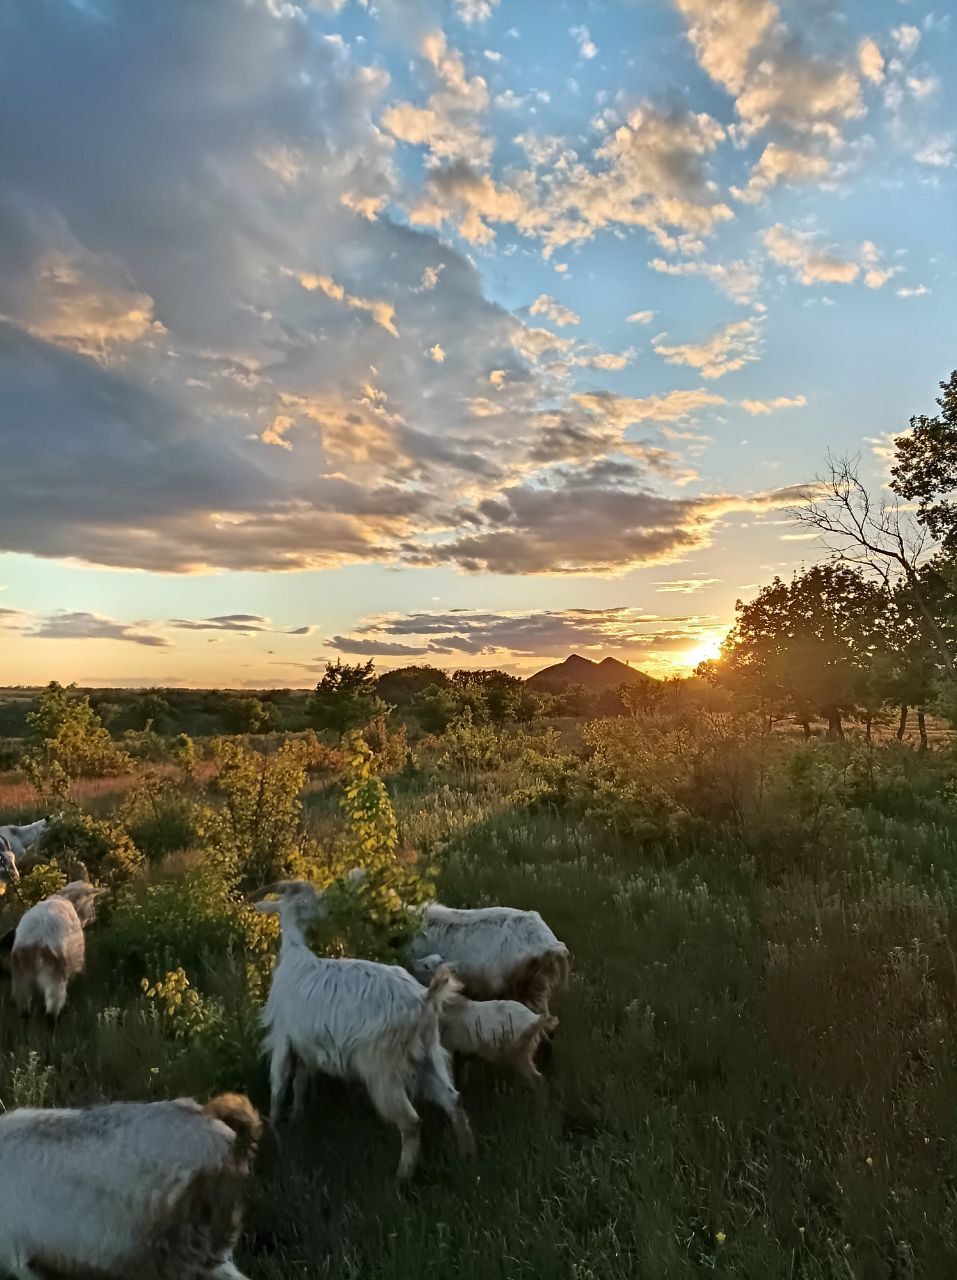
[0,0,957,687]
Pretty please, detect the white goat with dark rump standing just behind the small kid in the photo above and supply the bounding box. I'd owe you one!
[409,902,569,1014]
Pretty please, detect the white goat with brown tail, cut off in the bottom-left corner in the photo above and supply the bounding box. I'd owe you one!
[0,1094,261,1280]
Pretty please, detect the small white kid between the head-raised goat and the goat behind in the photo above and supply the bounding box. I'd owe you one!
[415,955,558,1080]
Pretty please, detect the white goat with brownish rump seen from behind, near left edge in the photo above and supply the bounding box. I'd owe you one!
[10,881,106,1018]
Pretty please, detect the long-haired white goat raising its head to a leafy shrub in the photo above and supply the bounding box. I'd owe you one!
[252,881,472,1178]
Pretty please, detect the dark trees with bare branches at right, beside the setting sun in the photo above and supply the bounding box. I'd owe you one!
[699,371,957,746]
